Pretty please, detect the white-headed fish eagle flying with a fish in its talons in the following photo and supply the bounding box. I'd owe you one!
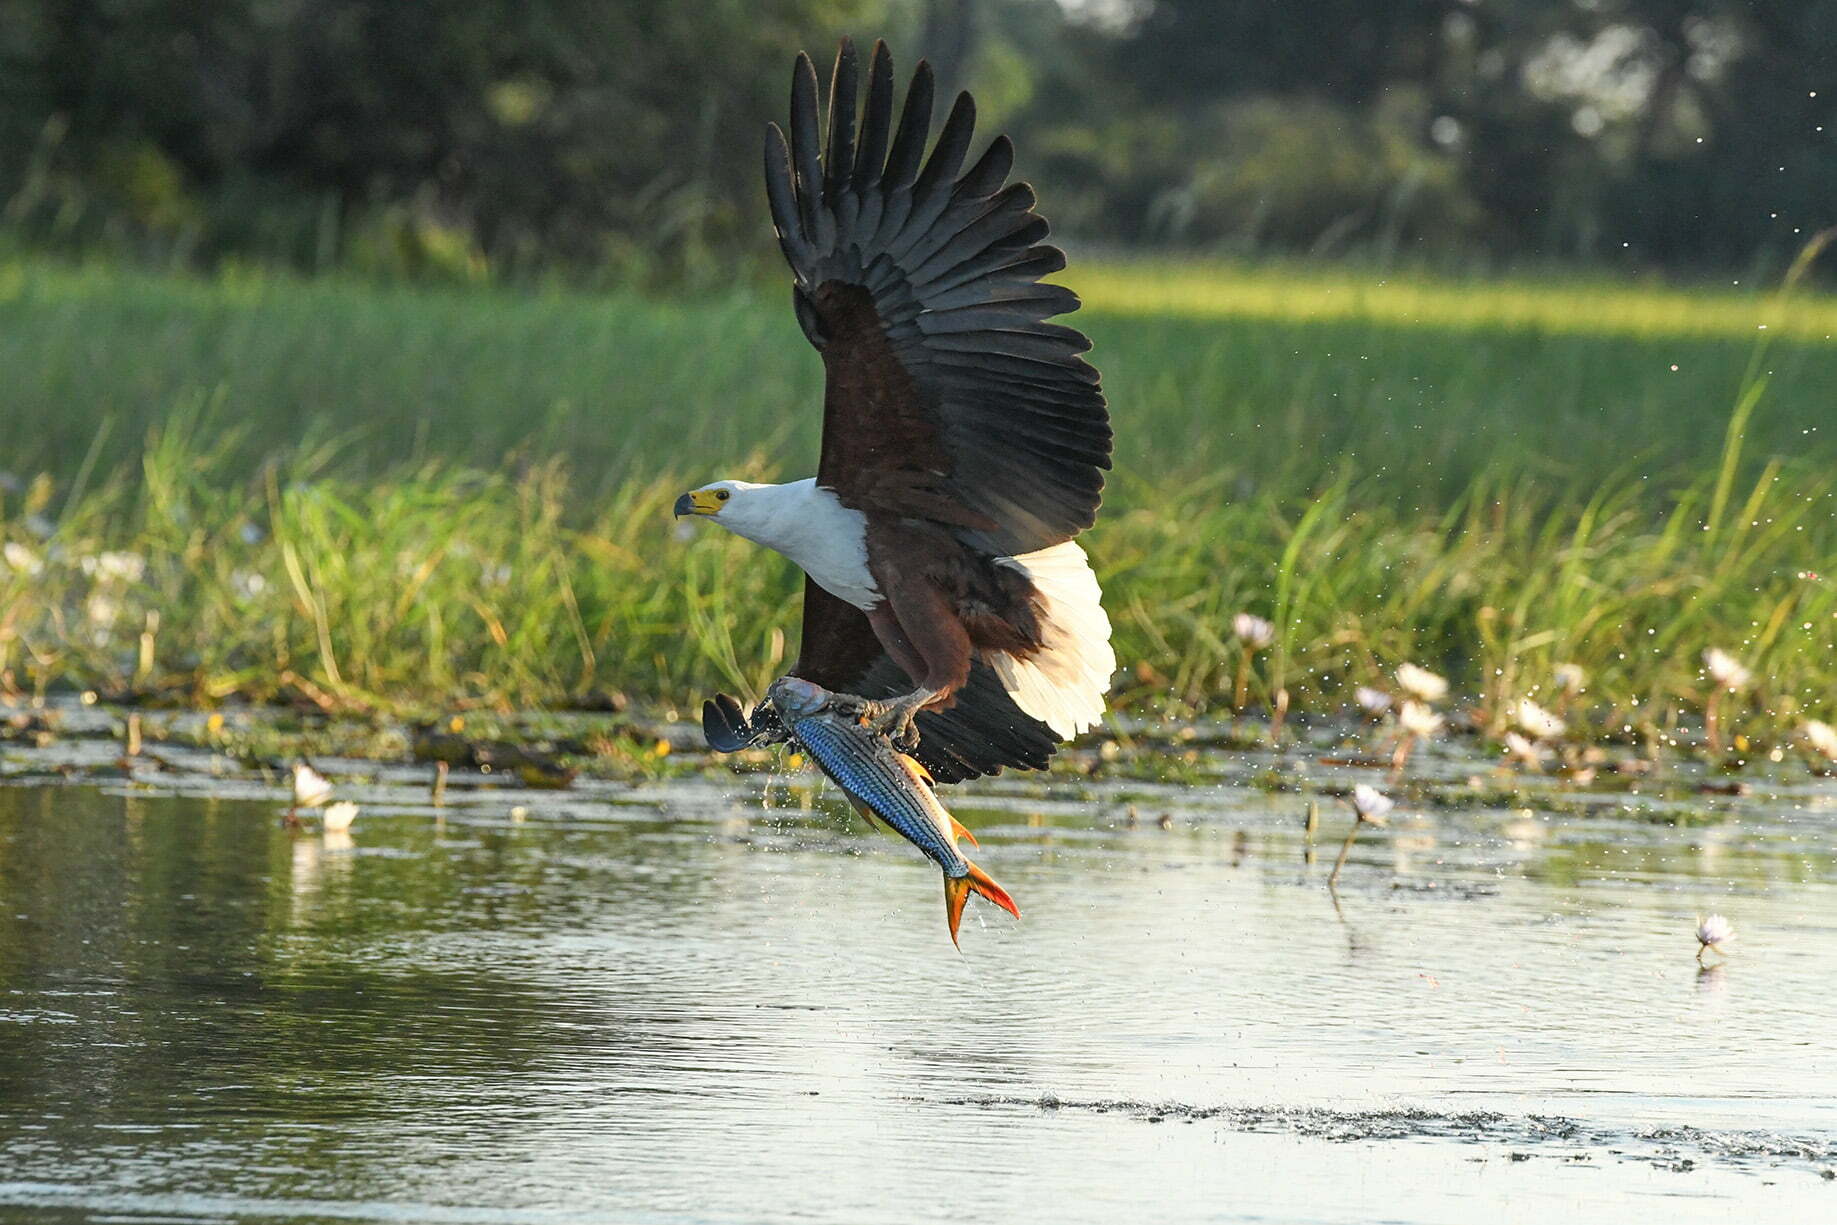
[676,40,1115,782]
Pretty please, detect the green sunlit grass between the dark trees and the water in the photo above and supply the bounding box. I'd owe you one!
[0,261,1837,735]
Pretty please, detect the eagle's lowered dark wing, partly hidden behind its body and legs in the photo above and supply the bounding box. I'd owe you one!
[792,580,1058,782]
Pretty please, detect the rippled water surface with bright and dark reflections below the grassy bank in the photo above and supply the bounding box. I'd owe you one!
[0,767,1837,1221]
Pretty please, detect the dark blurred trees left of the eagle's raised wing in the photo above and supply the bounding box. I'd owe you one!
[0,0,863,272]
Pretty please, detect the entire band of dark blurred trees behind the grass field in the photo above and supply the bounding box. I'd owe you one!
[0,0,1837,281]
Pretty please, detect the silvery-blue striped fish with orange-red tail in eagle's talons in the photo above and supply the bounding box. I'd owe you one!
[766,676,1021,944]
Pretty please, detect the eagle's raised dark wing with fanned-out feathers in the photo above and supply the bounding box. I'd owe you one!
[766,42,1111,555]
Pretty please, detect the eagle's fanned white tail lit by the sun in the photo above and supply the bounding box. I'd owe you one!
[988,540,1117,740]
